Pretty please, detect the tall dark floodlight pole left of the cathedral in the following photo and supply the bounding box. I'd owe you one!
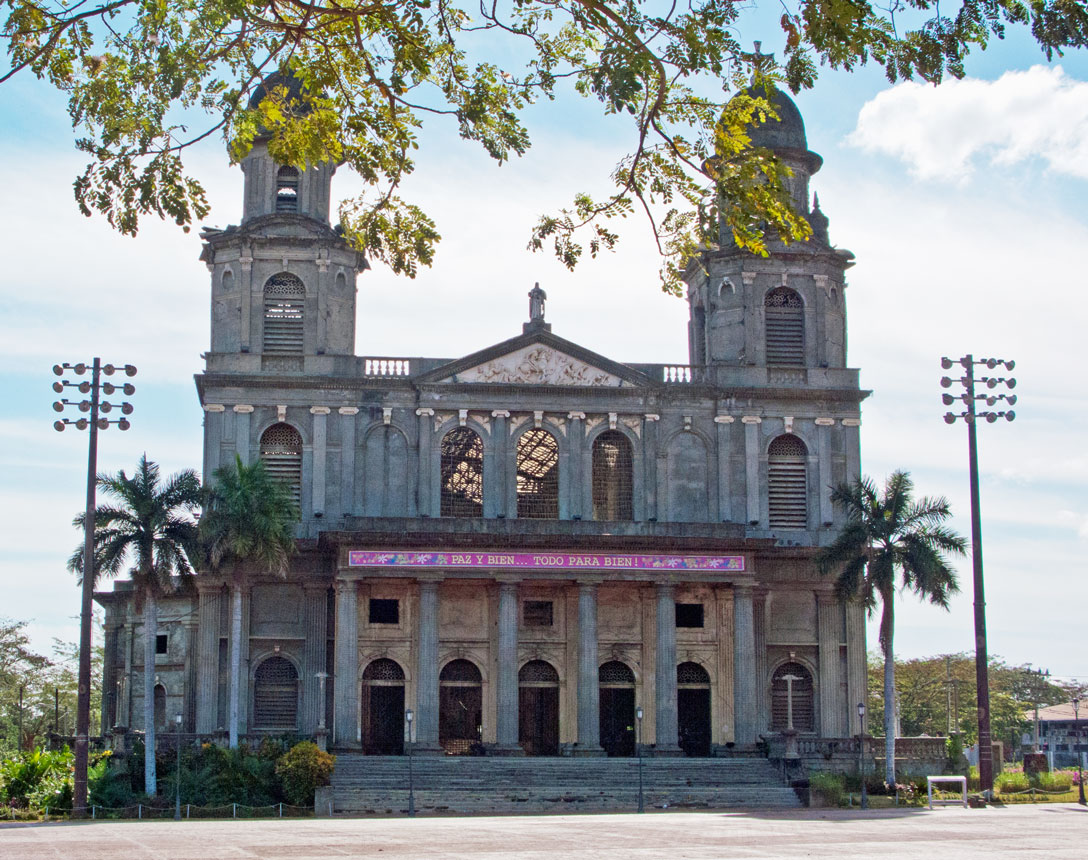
[53,357,136,819]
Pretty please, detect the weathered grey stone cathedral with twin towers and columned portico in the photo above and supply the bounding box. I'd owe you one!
[97,87,866,755]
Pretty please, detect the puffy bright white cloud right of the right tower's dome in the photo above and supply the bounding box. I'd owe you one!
[848,65,1088,181]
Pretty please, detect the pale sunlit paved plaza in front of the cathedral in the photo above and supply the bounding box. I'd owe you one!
[0,804,1088,860]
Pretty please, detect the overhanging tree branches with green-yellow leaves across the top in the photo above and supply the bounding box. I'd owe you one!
[0,0,1088,292]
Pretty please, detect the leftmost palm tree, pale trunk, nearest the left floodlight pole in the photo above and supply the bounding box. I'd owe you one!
[67,454,200,795]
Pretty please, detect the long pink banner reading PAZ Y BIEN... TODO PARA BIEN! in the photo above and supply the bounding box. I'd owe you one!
[347,550,744,572]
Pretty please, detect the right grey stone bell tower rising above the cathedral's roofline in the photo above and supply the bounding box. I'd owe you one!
[684,87,853,384]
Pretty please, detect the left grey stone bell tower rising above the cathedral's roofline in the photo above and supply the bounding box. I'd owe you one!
[201,72,368,372]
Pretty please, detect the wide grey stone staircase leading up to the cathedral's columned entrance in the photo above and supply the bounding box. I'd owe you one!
[319,753,801,815]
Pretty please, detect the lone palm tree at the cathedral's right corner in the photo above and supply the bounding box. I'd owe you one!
[816,471,967,785]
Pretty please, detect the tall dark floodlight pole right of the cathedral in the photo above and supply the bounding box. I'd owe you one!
[941,353,1016,796]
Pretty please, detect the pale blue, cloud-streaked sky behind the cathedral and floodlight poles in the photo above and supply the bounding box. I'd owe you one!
[0,10,1088,679]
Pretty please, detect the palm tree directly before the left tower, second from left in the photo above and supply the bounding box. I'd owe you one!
[200,455,298,749]
